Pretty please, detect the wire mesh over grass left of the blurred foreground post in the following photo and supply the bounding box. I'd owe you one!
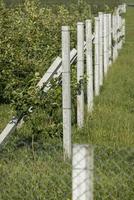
[0,143,72,200]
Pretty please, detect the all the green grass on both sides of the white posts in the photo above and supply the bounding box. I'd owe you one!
[0,8,134,200]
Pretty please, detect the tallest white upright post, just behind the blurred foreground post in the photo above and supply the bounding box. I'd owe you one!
[62,26,72,158]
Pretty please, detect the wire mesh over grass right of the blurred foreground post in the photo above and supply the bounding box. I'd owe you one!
[94,146,134,200]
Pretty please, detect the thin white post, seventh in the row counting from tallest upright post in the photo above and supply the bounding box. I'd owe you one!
[108,13,112,65]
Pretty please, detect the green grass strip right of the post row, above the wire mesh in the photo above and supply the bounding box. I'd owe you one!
[74,8,134,146]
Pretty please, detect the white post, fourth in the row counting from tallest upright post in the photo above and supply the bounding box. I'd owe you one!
[94,17,100,96]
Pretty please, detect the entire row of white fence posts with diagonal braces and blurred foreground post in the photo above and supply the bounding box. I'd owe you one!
[0,1,126,200]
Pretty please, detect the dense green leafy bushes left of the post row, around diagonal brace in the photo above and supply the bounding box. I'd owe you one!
[0,0,91,138]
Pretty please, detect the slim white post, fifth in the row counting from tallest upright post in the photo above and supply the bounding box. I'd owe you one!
[99,12,104,86]
